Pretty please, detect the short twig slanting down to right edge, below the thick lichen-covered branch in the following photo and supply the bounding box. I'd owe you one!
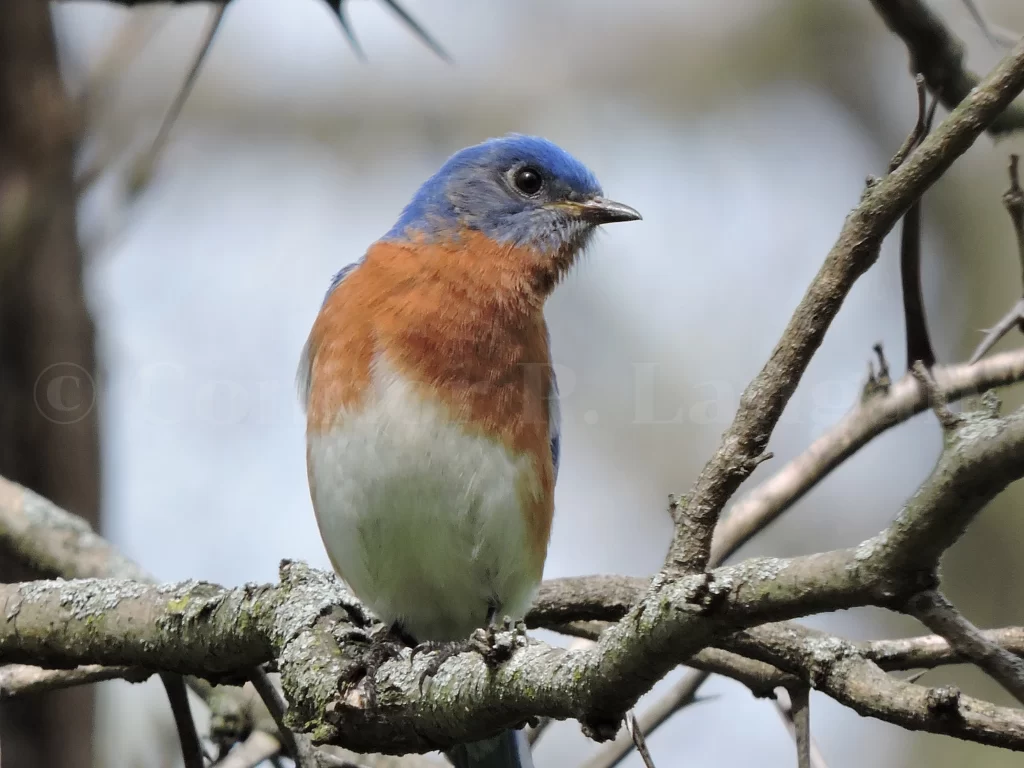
[907,590,1024,703]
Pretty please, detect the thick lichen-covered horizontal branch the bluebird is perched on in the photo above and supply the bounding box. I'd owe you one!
[6,382,1024,751]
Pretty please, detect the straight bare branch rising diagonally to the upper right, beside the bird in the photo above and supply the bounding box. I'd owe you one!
[666,36,1024,575]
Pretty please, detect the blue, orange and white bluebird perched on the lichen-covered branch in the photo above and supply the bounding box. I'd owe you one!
[299,134,640,768]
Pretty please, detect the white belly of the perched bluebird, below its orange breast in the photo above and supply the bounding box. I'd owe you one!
[308,360,539,641]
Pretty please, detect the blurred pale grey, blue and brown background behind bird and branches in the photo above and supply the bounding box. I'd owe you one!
[0,0,1024,768]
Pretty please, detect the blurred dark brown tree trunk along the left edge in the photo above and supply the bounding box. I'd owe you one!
[0,0,99,768]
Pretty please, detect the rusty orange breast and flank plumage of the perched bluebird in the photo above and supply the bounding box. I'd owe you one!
[307,233,554,568]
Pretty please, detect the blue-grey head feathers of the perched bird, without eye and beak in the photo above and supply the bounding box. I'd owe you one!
[384,134,602,252]
